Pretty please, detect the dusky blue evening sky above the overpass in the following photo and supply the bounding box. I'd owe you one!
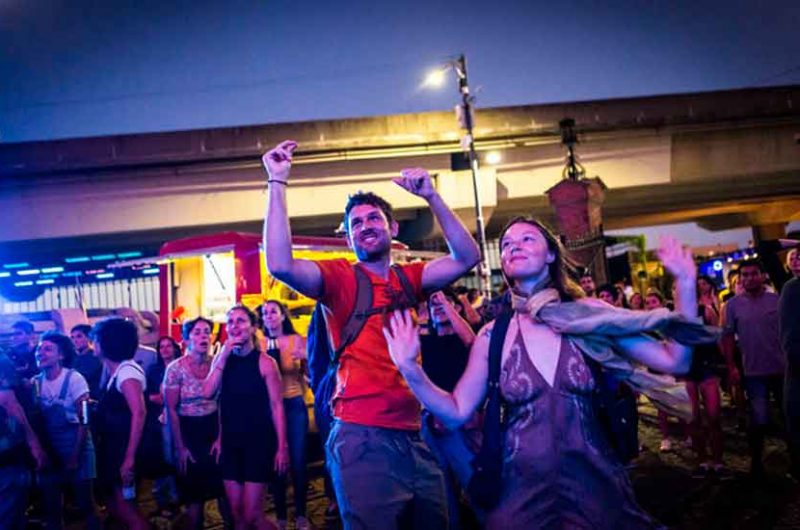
[0,0,800,142]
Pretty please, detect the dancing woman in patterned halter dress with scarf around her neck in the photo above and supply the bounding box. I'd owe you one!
[385,218,696,529]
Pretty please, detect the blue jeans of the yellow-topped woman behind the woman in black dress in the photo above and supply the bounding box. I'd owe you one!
[270,396,308,520]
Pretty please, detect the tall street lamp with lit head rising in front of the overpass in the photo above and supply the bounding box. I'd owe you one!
[423,54,491,296]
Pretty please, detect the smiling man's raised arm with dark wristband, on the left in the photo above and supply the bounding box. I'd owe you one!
[261,140,322,298]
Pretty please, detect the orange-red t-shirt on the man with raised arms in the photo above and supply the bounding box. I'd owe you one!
[317,259,425,430]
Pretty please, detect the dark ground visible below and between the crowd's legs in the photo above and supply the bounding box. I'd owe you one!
[59,396,800,530]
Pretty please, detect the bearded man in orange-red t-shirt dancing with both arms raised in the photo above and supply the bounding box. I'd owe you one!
[263,141,480,529]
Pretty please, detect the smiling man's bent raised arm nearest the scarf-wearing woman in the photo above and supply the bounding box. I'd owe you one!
[394,168,481,291]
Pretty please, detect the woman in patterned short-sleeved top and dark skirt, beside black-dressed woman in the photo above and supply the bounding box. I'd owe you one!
[164,317,224,529]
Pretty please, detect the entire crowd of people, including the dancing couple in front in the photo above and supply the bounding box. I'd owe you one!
[0,141,800,529]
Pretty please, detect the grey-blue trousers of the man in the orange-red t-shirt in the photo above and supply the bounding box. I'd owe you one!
[325,421,448,530]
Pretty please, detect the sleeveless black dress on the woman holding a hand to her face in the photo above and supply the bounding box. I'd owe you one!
[220,350,277,484]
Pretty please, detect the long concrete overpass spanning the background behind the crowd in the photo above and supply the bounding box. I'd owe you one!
[0,85,800,259]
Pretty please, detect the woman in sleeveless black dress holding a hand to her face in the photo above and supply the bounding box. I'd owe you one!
[203,305,289,528]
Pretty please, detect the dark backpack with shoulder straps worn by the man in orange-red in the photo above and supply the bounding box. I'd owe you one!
[306,264,416,424]
